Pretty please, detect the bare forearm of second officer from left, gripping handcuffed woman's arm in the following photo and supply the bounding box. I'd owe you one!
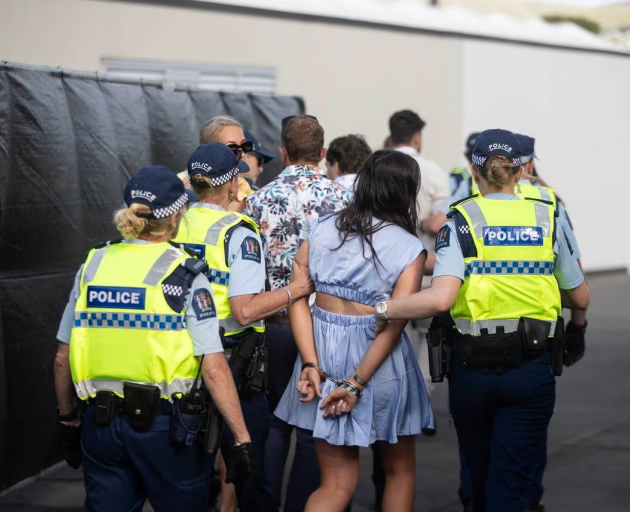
[230,264,313,325]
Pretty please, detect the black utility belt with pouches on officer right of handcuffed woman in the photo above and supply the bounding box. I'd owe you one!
[427,317,565,382]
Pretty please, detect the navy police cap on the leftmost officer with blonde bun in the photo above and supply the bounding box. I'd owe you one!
[125,165,199,219]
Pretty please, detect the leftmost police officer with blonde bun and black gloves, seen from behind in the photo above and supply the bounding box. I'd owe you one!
[55,166,255,512]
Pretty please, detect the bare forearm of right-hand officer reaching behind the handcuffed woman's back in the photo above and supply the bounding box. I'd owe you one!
[387,276,462,320]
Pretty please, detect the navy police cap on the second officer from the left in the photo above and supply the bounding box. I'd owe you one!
[188,142,249,187]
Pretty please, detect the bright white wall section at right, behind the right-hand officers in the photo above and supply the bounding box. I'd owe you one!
[461,40,630,270]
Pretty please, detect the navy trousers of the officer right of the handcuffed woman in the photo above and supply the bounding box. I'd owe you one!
[449,354,556,512]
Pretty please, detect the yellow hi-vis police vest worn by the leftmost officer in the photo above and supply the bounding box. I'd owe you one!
[70,242,199,400]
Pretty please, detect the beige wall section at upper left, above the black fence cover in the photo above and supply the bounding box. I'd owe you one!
[0,0,461,165]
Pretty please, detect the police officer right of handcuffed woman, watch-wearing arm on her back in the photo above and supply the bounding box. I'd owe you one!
[375,130,589,512]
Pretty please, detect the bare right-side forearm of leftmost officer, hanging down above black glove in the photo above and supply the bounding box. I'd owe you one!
[202,352,251,443]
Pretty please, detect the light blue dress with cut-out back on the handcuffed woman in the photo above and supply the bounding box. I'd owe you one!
[275,215,433,446]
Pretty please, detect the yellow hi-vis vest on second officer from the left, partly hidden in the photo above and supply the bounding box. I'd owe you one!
[175,205,265,336]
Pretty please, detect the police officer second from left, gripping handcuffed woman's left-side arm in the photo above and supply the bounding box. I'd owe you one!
[177,142,311,512]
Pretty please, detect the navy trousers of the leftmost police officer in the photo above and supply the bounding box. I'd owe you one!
[81,405,212,512]
